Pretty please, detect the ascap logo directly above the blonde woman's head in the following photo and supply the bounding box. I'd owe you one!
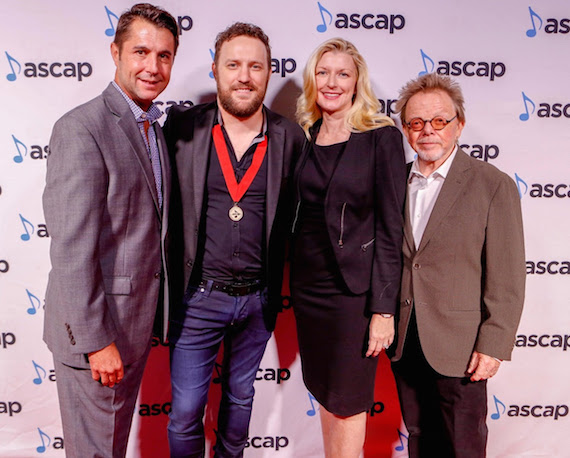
[317,2,406,34]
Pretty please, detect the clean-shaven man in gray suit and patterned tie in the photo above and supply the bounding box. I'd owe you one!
[43,4,178,458]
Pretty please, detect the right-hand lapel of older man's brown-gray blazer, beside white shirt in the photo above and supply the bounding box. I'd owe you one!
[411,148,470,253]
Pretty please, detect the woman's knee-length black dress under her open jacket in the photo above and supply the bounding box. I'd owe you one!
[291,142,378,416]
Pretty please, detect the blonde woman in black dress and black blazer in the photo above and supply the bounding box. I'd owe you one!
[291,38,406,458]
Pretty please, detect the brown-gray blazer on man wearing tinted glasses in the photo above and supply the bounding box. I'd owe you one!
[393,149,526,377]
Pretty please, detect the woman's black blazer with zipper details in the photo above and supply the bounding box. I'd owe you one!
[293,121,406,313]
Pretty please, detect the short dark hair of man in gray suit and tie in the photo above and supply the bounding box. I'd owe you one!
[113,3,178,54]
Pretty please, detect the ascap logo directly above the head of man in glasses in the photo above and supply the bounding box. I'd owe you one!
[418,49,507,81]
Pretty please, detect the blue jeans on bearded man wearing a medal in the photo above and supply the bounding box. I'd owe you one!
[168,281,271,457]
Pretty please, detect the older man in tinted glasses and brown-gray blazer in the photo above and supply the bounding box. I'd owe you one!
[393,73,525,458]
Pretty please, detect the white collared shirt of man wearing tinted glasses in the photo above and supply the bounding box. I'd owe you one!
[408,145,457,249]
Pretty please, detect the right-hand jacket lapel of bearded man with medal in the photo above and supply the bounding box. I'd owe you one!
[265,109,285,248]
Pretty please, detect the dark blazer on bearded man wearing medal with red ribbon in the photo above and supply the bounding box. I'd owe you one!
[163,102,305,329]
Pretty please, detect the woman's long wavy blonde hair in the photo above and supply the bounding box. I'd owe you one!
[296,38,394,138]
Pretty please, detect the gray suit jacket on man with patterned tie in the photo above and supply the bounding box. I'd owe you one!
[43,85,170,367]
